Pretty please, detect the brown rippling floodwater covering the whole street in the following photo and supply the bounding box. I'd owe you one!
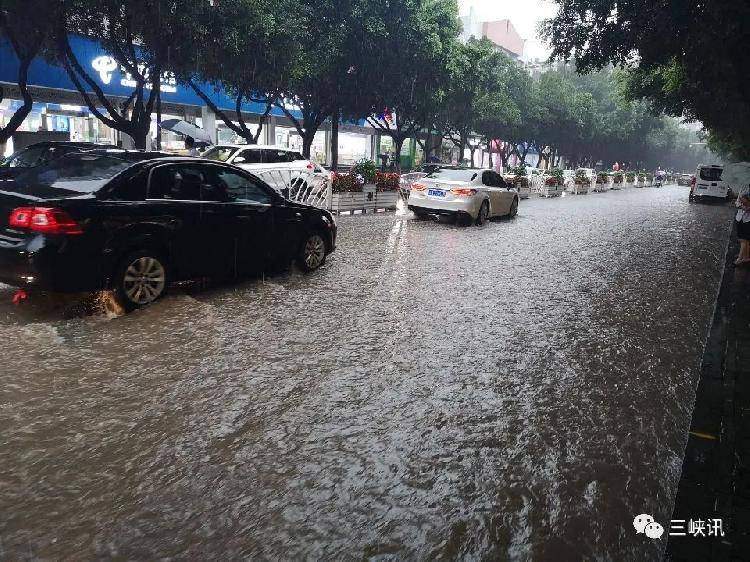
[0,186,732,561]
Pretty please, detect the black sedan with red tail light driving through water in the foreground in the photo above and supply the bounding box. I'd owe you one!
[0,153,336,309]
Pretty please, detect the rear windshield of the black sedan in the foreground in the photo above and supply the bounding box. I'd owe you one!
[16,154,132,193]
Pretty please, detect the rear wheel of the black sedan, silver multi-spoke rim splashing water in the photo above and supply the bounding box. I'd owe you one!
[113,250,168,311]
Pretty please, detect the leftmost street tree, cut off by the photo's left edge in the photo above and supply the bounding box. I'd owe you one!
[0,0,53,147]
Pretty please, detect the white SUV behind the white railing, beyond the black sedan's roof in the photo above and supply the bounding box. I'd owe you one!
[201,144,330,196]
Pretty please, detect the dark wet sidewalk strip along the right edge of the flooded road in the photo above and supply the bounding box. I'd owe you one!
[665,222,750,562]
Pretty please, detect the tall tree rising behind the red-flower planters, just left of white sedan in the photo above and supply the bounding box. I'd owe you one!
[367,0,458,169]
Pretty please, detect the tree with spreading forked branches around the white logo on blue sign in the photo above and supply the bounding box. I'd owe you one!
[55,0,206,148]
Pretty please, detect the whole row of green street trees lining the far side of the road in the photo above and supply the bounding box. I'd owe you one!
[0,0,700,166]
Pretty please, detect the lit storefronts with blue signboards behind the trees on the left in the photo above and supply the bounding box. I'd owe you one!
[0,36,388,164]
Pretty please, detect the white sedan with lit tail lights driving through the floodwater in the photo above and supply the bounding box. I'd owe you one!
[409,167,518,225]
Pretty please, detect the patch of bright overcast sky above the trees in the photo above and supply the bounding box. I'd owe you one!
[458,0,557,59]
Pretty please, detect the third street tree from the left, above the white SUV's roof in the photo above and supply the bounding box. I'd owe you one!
[175,0,299,144]
